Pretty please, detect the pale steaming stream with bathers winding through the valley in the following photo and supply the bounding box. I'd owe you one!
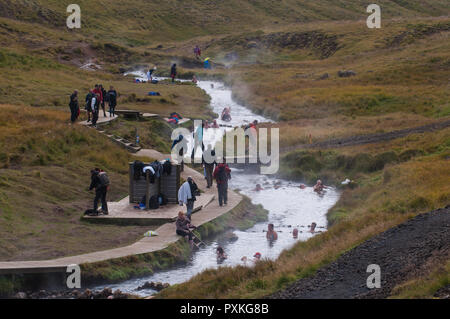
[93,72,339,296]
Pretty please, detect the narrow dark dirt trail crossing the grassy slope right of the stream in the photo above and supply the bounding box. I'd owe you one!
[280,120,450,153]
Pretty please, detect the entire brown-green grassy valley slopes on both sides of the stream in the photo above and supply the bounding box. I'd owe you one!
[0,0,450,298]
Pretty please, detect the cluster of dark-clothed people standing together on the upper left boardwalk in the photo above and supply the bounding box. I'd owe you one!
[69,84,117,127]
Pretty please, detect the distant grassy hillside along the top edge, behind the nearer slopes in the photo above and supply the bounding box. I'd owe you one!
[0,0,449,46]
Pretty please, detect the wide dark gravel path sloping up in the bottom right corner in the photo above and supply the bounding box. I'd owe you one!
[270,205,450,299]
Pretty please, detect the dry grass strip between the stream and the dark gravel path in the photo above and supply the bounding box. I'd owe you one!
[159,136,450,298]
